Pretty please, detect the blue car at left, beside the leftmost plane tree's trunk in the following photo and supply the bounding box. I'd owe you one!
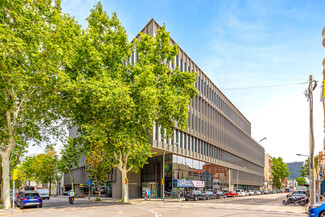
[15,191,43,209]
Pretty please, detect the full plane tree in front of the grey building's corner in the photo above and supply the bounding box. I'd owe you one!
[66,3,197,202]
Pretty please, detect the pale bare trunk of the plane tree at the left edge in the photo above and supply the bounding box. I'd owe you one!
[1,152,10,209]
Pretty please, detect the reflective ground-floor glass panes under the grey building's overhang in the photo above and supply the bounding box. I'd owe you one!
[141,154,229,198]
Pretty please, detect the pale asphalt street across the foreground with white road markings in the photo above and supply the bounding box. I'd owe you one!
[5,194,307,217]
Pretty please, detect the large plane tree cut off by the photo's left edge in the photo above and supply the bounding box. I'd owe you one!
[0,0,80,209]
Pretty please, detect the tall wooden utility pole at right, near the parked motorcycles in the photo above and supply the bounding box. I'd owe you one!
[305,75,317,205]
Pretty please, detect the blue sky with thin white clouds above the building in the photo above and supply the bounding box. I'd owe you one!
[43,0,325,162]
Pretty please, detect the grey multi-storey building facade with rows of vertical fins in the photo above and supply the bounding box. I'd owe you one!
[64,19,265,198]
